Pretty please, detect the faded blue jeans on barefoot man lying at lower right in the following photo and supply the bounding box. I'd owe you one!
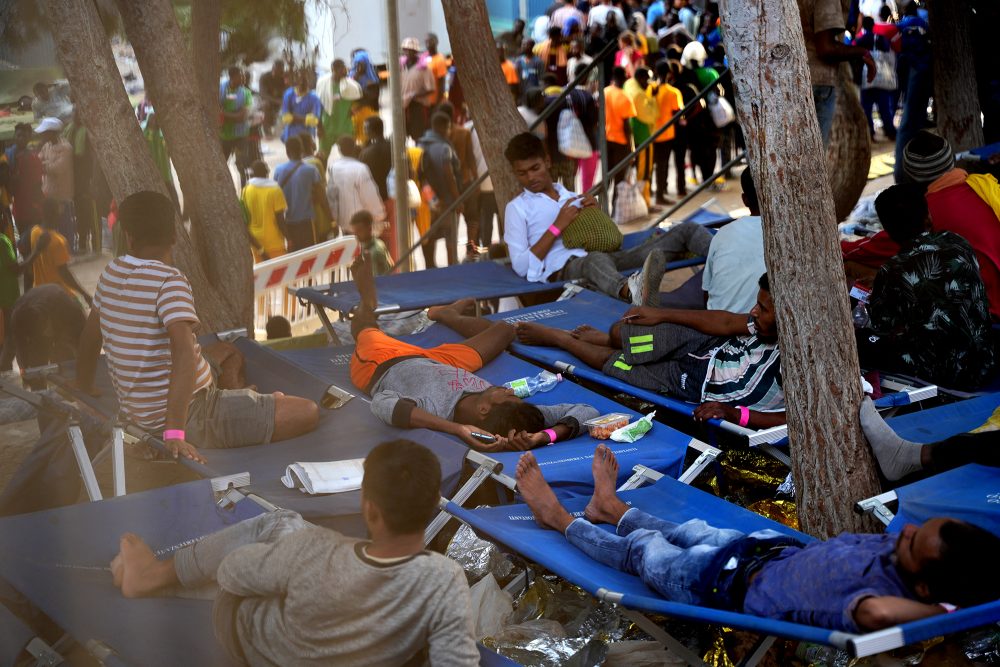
[566,507,782,605]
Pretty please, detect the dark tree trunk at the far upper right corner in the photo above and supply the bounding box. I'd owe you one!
[927,0,984,153]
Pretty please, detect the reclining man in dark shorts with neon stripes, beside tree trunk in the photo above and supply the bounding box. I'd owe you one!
[516,273,785,428]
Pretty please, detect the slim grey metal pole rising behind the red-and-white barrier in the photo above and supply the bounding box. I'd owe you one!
[385,0,413,271]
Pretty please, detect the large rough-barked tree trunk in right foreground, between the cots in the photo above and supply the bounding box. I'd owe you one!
[720,0,879,537]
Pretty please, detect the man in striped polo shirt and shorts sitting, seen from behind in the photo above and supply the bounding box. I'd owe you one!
[76,192,319,462]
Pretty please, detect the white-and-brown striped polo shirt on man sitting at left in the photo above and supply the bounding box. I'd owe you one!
[94,255,212,430]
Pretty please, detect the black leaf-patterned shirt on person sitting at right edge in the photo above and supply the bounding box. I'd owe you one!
[868,232,996,388]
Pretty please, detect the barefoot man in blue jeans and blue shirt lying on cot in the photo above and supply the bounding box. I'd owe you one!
[517,445,1000,632]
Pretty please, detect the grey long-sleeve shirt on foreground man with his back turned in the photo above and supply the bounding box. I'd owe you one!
[217,527,479,667]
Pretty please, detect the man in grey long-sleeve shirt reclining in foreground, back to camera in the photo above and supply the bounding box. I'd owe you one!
[111,440,479,666]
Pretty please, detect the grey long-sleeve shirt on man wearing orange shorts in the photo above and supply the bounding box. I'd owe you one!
[372,358,599,440]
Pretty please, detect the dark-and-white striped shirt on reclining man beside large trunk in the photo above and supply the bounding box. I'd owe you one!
[702,317,785,412]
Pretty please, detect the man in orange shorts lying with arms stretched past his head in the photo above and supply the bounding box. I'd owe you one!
[351,257,598,451]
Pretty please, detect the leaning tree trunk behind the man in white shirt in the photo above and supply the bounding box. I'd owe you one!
[442,0,528,219]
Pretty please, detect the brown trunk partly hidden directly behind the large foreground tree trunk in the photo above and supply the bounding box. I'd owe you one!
[826,63,872,221]
